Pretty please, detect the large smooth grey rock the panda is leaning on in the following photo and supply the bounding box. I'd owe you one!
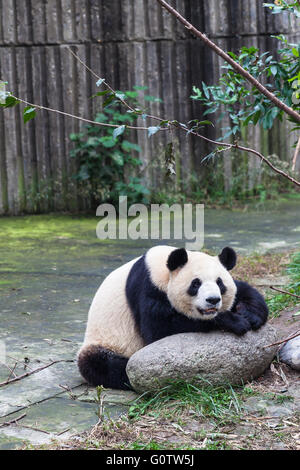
[126,324,277,392]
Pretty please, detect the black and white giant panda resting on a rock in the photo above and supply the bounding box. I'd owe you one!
[78,246,268,390]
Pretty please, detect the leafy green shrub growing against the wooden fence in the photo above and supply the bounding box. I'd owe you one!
[70,91,149,207]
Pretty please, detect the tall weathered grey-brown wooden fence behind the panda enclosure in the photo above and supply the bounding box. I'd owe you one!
[0,0,300,214]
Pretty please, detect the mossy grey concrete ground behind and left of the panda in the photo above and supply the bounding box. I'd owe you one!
[0,201,300,449]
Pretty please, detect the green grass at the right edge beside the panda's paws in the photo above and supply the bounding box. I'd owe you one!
[266,252,300,317]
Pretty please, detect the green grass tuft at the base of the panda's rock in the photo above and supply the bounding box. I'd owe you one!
[129,380,241,424]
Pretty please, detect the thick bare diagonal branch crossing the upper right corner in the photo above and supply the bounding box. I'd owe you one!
[157,0,300,122]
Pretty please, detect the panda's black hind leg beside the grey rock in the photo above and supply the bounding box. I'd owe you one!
[78,345,132,390]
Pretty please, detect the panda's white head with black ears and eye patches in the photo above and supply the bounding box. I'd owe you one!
[167,247,237,320]
